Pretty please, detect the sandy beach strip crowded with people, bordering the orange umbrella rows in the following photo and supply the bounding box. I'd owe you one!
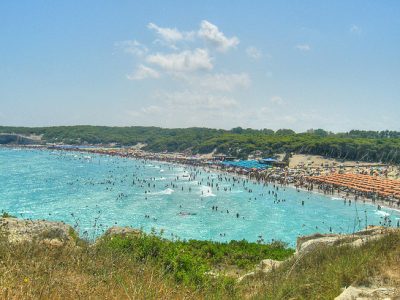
[46,145,400,208]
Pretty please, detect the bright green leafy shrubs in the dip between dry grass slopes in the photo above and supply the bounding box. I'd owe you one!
[100,233,294,288]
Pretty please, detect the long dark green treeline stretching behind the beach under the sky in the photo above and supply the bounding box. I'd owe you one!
[0,126,400,163]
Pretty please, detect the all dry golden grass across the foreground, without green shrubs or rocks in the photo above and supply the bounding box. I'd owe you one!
[0,227,400,299]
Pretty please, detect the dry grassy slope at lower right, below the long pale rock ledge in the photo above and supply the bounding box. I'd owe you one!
[248,232,400,299]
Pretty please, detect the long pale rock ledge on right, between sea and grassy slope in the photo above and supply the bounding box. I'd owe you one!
[296,226,395,255]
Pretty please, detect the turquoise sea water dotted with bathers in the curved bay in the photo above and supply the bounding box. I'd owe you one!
[0,148,400,246]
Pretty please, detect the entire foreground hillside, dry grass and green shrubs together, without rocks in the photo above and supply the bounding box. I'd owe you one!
[0,221,400,299]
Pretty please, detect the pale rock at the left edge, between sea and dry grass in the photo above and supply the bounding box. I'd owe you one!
[0,218,77,246]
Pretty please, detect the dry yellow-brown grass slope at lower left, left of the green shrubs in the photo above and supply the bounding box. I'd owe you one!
[0,241,204,299]
